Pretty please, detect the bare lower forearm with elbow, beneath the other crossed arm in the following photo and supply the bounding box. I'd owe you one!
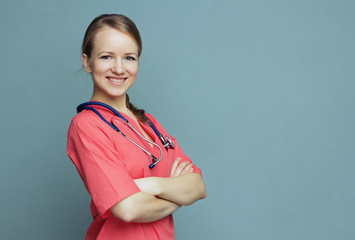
[110,192,180,222]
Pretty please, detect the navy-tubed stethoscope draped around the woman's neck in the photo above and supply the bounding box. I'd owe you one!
[76,101,175,169]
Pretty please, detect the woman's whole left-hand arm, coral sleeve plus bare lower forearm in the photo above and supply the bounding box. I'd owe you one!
[68,116,180,222]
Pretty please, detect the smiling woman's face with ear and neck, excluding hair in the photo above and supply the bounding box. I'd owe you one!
[82,27,139,100]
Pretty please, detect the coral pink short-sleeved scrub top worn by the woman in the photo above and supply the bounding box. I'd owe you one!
[67,106,201,240]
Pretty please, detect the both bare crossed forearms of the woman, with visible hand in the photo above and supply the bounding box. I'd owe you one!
[111,158,206,222]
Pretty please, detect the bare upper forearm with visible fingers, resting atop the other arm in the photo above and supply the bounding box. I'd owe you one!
[134,158,206,205]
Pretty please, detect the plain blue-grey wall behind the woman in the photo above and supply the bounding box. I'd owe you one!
[0,0,355,240]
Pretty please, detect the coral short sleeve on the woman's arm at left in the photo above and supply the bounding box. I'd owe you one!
[67,112,140,217]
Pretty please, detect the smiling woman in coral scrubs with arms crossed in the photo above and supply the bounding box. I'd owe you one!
[67,14,206,240]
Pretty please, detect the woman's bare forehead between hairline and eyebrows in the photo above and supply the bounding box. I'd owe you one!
[93,27,138,53]
